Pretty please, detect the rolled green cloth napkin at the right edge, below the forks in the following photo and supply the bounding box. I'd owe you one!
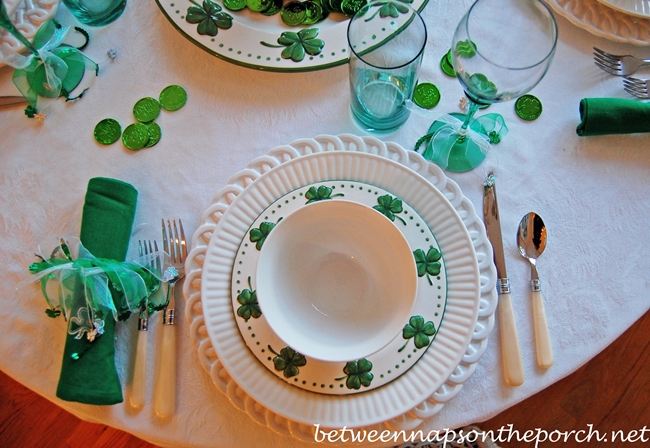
[576,98,650,137]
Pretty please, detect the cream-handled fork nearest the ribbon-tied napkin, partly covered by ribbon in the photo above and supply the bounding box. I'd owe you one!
[129,240,160,409]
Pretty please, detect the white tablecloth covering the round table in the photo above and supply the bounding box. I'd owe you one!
[0,0,650,447]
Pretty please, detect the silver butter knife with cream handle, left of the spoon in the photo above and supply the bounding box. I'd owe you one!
[483,173,524,387]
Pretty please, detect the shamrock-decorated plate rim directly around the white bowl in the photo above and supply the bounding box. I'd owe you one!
[231,180,447,395]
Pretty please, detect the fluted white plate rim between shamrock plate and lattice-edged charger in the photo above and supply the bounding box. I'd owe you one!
[201,146,481,428]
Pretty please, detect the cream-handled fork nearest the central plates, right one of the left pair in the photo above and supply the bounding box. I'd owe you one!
[155,219,187,418]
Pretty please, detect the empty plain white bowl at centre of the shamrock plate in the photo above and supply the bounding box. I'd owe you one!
[256,200,417,362]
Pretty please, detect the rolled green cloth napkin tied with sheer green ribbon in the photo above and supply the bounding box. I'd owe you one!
[56,177,138,405]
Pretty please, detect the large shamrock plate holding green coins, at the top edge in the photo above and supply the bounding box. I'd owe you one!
[156,0,428,72]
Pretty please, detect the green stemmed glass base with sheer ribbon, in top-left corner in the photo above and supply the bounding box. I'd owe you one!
[0,0,99,119]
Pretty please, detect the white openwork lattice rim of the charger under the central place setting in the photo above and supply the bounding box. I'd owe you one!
[183,135,497,441]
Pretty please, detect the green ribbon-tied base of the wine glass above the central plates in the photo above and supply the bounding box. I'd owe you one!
[423,121,486,173]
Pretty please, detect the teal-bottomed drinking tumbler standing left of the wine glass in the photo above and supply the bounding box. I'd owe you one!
[348,0,427,133]
